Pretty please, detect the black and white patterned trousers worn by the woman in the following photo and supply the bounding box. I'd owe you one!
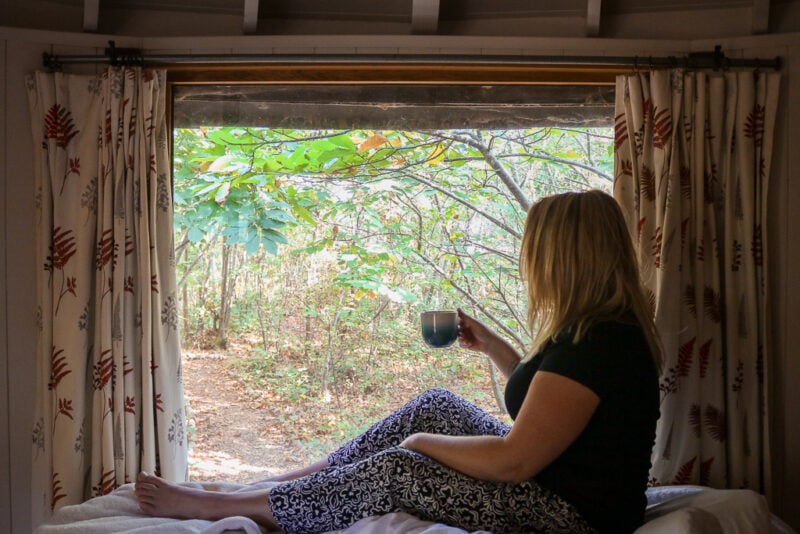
[269,389,595,534]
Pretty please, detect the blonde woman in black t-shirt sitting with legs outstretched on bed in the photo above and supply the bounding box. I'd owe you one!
[136,191,660,533]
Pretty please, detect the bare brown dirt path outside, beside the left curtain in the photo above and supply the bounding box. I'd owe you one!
[183,351,305,483]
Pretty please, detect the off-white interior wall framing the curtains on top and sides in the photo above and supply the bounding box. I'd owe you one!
[0,23,800,533]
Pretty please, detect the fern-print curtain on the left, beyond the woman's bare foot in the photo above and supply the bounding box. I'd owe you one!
[27,67,187,519]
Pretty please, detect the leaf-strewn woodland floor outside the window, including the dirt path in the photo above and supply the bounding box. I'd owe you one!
[182,345,501,483]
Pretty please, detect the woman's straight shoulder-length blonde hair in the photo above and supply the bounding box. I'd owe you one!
[519,190,661,369]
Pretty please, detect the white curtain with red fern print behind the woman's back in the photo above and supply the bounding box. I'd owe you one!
[614,70,779,493]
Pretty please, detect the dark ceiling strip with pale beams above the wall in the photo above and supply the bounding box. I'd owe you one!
[0,0,800,37]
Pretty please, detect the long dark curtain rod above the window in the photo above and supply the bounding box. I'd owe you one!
[43,41,781,70]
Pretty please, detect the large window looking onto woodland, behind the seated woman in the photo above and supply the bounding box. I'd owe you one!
[173,80,613,481]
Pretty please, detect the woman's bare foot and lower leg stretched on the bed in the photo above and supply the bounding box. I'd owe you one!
[134,473,277,528]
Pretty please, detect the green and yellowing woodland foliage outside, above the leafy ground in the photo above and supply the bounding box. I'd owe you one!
[175,128,613,448]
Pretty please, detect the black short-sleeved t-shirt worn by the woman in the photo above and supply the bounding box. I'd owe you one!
[505,321,659,534]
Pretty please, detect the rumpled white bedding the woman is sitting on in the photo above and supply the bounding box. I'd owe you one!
[35,482,795,534]
